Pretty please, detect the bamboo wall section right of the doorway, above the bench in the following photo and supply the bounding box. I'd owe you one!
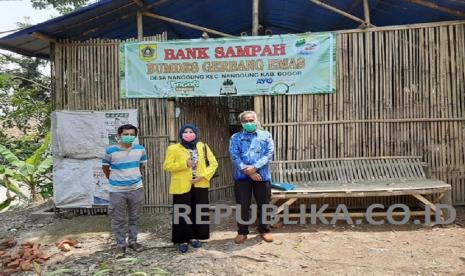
[255,22,465,204]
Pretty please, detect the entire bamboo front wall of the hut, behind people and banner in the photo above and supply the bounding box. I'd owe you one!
[52,23,465,212]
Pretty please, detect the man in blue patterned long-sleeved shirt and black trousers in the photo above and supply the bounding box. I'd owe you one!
[229,111,274,244]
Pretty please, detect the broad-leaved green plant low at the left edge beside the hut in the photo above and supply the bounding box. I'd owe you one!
[0,133,53,210]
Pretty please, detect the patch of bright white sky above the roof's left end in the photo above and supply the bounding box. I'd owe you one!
[0,0,59,37]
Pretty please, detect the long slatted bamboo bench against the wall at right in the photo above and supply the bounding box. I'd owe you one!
[270,156,451,221]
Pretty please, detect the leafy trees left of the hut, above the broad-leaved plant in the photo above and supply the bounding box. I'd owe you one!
[0,54,51,160]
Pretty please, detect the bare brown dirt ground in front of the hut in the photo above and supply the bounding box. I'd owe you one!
[0,204,465,275]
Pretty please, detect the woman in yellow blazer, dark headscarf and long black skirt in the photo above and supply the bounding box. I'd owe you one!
[163,124,218,253]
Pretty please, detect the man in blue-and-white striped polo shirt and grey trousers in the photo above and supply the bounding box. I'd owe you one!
[102,124,147,258]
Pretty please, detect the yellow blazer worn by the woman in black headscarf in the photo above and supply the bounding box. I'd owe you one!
[163,142,218,195]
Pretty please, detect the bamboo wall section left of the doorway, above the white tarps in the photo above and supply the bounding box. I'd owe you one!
[52,34,169,212]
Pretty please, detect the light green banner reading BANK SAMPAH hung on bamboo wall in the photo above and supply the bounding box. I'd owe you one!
[120,32,336,98]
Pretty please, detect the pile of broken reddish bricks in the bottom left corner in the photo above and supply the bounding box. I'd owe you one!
[0,238,50,275]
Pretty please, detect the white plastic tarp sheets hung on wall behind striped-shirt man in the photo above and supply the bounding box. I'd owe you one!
[52,109,138,208]
